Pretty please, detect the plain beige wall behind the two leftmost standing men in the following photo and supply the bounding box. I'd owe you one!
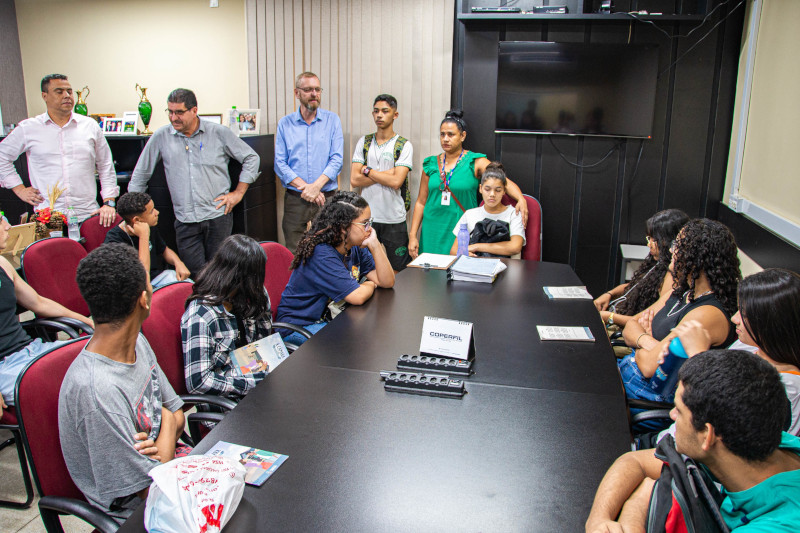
[16,0,248,129]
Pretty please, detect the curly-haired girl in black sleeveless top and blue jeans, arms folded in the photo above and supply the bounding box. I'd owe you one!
[619,218,742,402]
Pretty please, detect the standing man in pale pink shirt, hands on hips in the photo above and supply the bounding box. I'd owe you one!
[0,74,119,223]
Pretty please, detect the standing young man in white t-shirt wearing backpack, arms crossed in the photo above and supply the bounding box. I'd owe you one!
[350,94,414,273]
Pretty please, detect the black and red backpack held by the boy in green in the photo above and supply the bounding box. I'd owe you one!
[647,435,730,533]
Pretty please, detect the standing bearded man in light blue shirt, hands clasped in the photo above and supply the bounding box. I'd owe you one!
[275,72,344,252]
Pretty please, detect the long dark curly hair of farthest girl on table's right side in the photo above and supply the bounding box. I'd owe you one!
[614,209,690,315]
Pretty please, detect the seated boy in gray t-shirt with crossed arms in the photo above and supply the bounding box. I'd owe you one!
[58,244,185,521]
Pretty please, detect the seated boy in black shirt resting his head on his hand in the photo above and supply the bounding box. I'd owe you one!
[105,192,189,289]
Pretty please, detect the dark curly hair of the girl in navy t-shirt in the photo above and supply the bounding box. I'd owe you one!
[292,191,369,270]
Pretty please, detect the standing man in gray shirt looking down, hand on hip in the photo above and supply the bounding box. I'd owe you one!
[128,89,261,276]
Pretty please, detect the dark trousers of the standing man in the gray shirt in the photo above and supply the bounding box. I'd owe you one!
[175,212,233,279]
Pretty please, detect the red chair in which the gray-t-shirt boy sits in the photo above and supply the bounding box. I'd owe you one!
[16,339,119,533]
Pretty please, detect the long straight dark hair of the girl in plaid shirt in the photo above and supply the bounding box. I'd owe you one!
[186,234,272,319]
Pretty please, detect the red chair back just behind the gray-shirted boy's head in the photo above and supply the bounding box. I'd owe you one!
[20,237,89,316]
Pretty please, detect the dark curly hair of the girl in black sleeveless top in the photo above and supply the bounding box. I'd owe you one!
[672,218,742,316]
